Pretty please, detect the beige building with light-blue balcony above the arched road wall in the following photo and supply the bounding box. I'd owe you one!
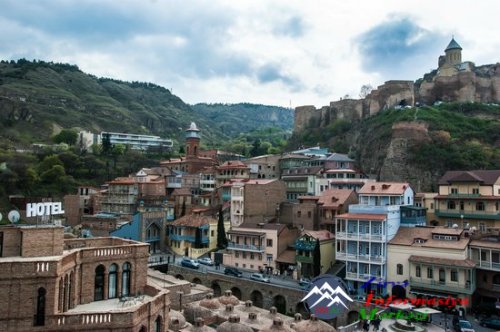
[224,223,300,273]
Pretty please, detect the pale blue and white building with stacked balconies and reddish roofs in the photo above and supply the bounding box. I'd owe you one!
[336,182,414,294]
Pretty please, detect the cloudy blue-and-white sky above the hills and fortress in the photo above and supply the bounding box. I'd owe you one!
[0,0,500,107]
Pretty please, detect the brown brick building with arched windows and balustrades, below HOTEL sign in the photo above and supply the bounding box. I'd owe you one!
[0,225,170,332]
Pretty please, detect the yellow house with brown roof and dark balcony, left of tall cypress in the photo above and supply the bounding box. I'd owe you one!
[167,215,230,258]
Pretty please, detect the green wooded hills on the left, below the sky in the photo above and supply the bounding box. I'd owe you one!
[0,59,293,148]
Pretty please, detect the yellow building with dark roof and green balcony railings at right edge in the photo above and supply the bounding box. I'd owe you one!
[434,170,500,233]
